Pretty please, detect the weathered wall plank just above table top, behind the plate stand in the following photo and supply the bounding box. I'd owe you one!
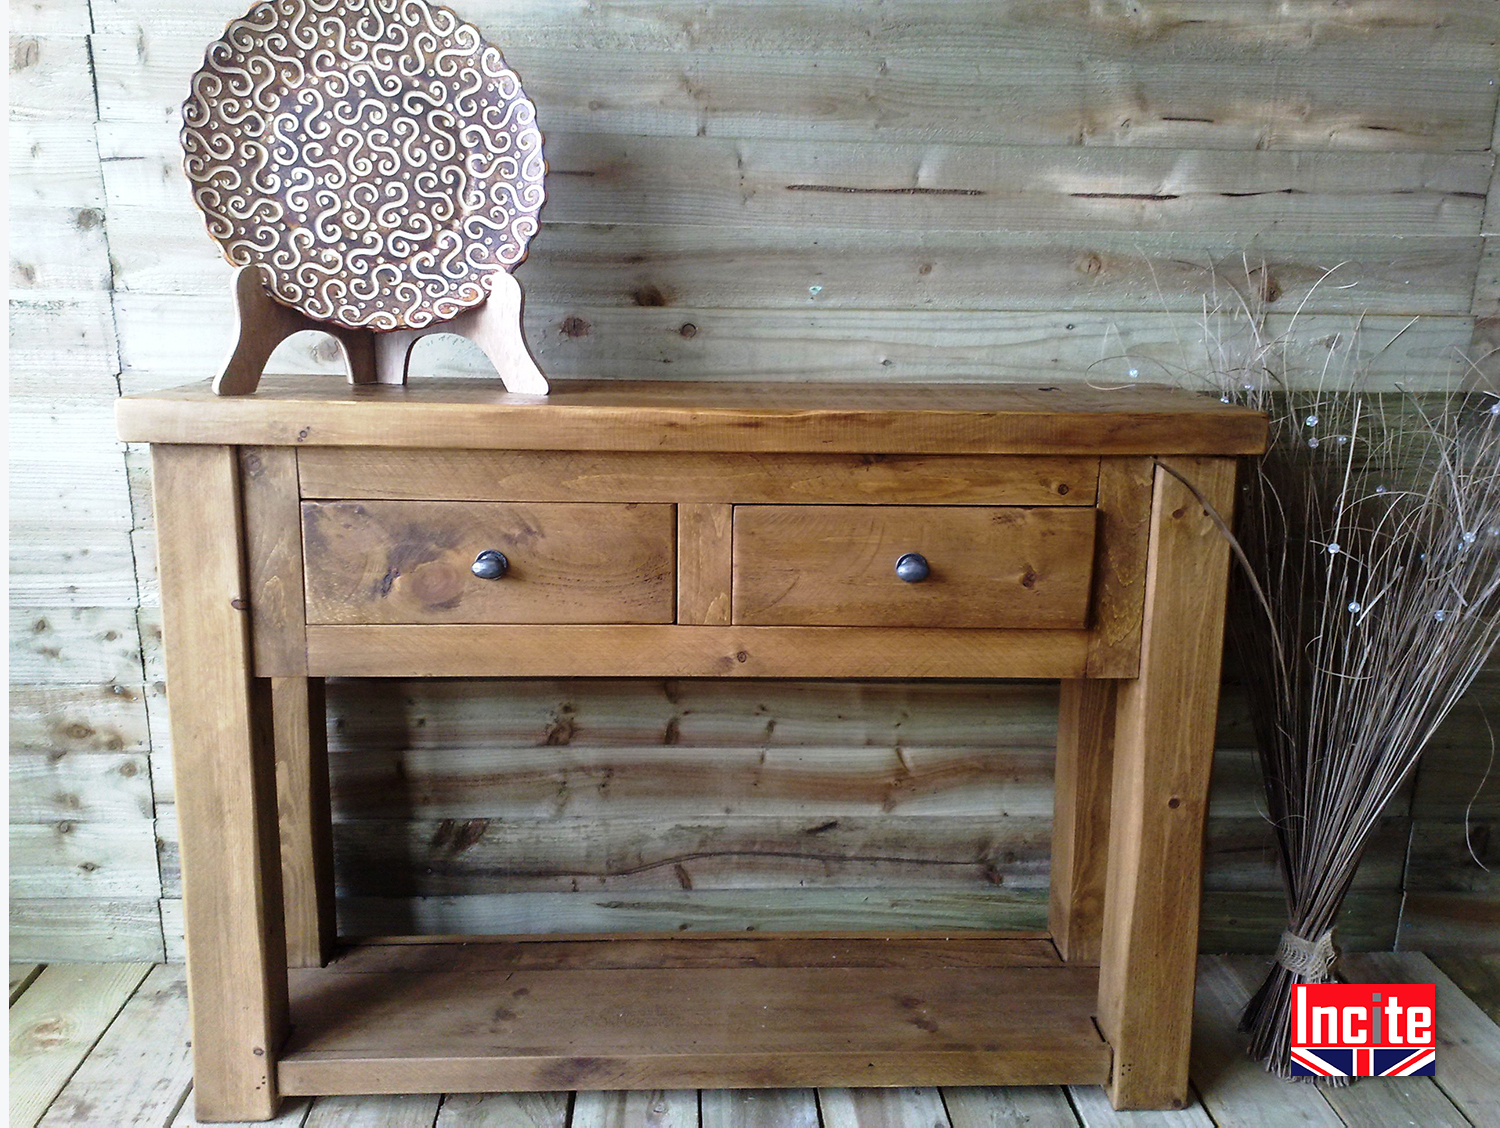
[108,294,1475,387]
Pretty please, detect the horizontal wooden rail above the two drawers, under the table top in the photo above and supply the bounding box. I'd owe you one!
[297,447,1098,506]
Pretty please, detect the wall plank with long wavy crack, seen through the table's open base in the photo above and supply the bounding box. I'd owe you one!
[159,797,1407,899]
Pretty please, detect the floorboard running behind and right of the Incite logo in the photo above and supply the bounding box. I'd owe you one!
[1343,953,1500,1125]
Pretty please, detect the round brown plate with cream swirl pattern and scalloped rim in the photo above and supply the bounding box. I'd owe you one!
[182,0,546,330]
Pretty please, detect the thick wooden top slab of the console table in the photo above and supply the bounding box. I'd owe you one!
[117,374,1266,455]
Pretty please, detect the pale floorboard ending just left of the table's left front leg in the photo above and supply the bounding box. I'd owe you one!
[42,965,192,1128]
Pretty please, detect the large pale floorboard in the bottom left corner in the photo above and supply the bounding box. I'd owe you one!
[11,963,152,1128]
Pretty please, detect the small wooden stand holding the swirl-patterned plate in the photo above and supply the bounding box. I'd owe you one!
[213,266,548,396]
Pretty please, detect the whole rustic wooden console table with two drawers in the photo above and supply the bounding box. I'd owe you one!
[119,377,1266,1121]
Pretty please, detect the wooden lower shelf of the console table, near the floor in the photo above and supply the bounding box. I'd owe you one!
[278,938,1110,1095]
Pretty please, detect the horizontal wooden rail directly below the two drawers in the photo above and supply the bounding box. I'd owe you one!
[308,624,1089,678]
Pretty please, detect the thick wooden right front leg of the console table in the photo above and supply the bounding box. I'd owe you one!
[1098,459,1236,1109]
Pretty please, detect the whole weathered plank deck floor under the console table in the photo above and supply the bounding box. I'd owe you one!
[11,954,1500,1128]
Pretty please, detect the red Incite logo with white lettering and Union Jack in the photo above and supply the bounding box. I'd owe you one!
[1292,983,1437,1077]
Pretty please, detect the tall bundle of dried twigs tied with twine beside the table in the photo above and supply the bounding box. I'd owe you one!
[1205,292,1500,1083]
